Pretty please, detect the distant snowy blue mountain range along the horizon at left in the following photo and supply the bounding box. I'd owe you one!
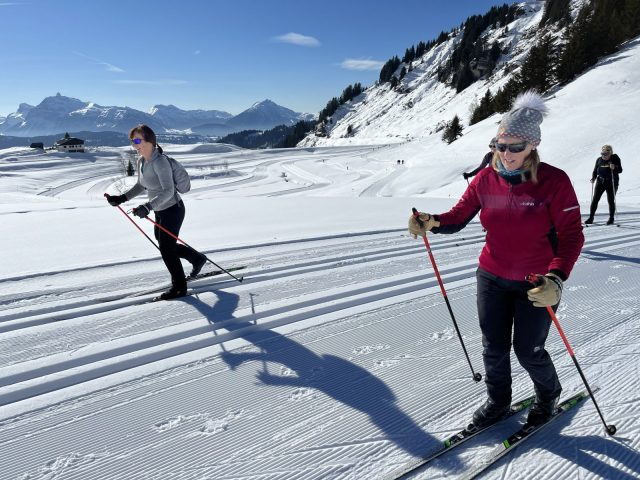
[0,93,313,137]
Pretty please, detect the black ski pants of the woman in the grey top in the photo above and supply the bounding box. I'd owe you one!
[153,200,200,288]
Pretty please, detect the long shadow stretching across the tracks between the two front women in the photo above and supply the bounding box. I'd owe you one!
[194,290,460,464]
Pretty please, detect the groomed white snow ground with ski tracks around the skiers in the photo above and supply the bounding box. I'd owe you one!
[0,41,640,480]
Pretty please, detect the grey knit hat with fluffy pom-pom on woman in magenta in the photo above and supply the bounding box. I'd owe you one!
[497,90,547,147]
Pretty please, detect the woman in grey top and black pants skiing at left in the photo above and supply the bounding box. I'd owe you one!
[107,125,206,300]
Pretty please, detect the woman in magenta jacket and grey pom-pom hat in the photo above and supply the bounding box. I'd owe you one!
[409,91,584,427]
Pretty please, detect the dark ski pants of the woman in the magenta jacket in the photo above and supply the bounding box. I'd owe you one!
[476,269,562,405]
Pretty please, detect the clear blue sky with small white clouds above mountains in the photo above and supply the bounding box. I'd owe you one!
[0,0,509,115]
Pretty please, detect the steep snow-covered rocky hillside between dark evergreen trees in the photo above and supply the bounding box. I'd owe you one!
[300,1,544,146]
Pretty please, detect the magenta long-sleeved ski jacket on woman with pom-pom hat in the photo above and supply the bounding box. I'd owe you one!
[432,163,584,281]
